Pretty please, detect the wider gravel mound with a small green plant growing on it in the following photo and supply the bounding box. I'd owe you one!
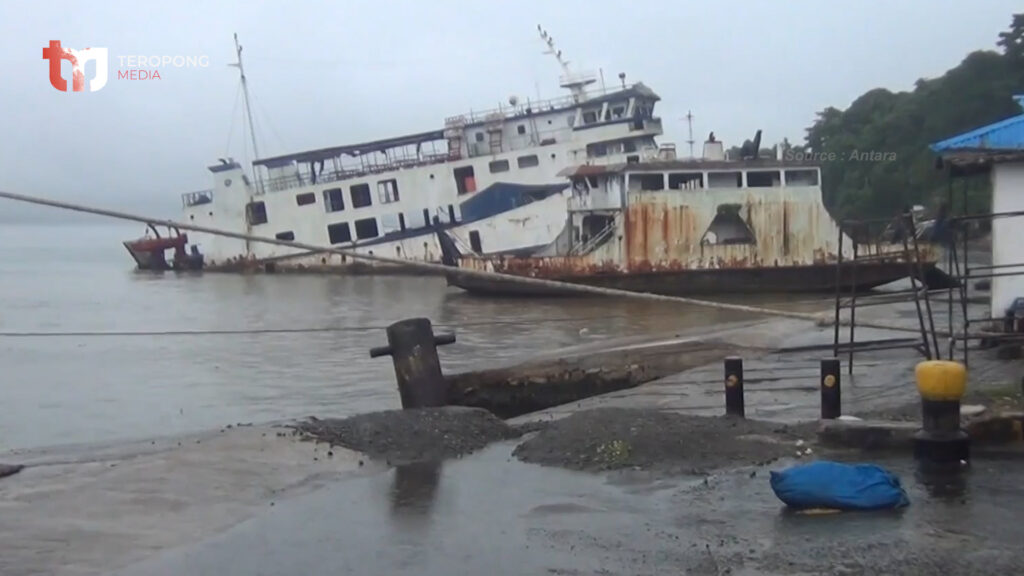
[514,408,813,475]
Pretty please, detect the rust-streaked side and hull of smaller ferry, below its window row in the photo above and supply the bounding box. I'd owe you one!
[440,179,936,295]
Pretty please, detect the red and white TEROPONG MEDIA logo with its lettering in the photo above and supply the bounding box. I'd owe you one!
[43,40,210,92]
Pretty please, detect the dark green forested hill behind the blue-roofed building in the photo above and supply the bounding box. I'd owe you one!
[798,14,1024,217]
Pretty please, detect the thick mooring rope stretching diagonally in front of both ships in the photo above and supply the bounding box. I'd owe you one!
[0,191,942,331]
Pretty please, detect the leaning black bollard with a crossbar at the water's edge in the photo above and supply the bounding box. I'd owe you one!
[370,318,455,409]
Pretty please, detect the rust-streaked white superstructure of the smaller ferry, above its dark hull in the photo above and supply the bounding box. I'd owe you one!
[538,136,835,256]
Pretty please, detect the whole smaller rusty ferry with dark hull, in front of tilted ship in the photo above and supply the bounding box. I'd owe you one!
[438,154,943,295]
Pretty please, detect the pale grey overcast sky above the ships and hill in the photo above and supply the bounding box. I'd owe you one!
[0,0,1021,219]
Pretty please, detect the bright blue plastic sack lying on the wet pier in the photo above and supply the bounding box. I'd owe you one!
[771,460,910,510]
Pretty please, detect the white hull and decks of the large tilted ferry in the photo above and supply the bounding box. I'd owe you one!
[183,77,662,266]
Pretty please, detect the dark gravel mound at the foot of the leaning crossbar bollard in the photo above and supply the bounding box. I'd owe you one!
[293,407,519,464]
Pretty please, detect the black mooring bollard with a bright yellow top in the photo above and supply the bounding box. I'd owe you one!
[913,360,971,468]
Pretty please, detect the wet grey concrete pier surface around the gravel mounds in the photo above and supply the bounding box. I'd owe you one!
[6,284,1024,576]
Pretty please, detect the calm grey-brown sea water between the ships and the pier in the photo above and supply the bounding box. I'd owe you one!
[0,220,827,450]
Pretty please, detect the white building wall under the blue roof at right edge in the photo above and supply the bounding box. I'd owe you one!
[991,162,1024,318]
